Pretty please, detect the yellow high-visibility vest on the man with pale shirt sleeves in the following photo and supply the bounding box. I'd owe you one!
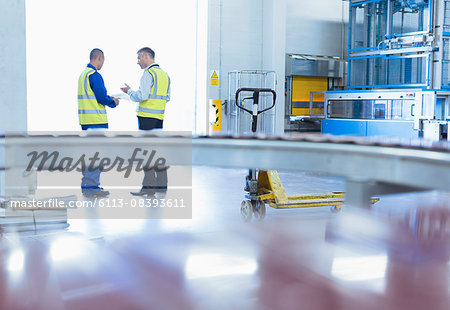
[137,65,170,120]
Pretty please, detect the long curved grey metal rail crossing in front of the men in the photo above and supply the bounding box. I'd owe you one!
[0,133,450,207]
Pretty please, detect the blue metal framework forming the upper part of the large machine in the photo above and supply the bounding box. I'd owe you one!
[347,0,432,89]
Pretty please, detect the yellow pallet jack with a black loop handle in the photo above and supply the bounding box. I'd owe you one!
[235,88,380,222]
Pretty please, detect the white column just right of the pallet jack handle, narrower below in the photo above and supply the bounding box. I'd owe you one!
[262,0,286,135]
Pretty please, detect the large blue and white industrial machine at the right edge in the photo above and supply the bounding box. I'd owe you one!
[322,0,450,140]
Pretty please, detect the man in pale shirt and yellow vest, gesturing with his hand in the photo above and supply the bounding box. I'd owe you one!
[121,47,170,196]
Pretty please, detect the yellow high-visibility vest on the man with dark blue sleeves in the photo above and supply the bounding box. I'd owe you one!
[78,67,108,125]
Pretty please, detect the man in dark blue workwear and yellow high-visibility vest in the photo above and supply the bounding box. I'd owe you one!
[78,48,119,198]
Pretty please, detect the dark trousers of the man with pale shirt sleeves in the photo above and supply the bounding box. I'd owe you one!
[138,116,167,192]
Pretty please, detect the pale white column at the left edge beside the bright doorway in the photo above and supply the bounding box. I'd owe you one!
[0,0,27,131]
